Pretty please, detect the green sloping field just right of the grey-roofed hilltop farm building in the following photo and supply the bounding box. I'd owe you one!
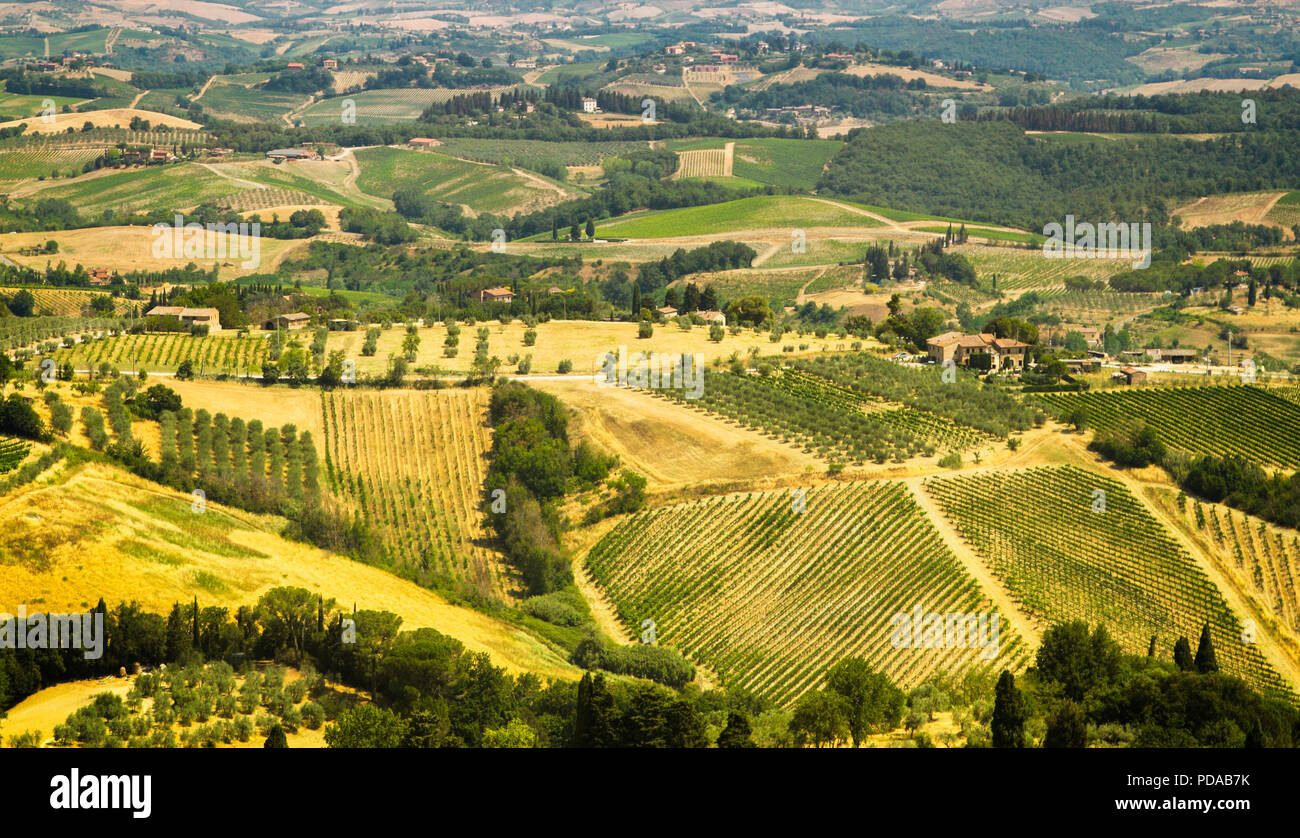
[355,147,569,214]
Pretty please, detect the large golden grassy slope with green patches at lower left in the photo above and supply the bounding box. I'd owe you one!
[0,465,581,679]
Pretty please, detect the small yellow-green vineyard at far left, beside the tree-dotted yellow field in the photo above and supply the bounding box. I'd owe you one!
[56,333,267,374]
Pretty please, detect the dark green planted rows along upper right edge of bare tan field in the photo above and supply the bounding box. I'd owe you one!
[650,369,982,465]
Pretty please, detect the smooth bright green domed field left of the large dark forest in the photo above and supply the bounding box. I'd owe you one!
[597,195,880,239]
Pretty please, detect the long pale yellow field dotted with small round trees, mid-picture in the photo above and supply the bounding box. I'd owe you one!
[328,320,840,377]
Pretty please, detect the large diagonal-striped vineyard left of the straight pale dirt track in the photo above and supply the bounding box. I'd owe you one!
[586,482,1027,704]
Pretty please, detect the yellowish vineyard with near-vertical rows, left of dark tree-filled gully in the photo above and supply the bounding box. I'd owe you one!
[324,390,512,599]
